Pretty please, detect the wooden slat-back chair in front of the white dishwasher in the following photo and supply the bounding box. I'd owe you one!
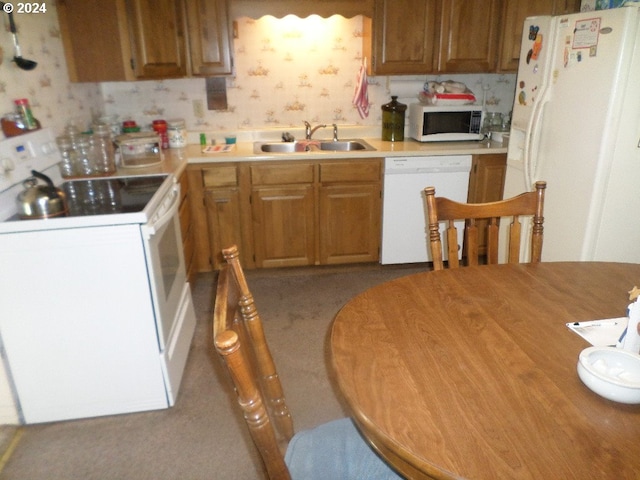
[424,181,547,270]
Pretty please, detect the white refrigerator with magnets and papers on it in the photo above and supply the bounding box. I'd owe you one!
[504,6,640,263]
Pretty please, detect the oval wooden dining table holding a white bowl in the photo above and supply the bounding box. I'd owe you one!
[330,262,640,480]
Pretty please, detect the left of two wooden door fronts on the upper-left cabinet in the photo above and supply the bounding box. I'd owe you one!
[128,0,187,79]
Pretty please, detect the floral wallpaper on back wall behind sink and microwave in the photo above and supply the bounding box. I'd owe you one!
[102,15,515,139]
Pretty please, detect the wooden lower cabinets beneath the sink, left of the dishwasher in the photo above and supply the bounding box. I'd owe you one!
[188,158,382,271]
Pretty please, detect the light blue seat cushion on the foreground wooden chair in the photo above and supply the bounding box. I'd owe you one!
[285,418,402,480]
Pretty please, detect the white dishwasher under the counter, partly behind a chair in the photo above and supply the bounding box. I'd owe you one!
[380,155,471,264]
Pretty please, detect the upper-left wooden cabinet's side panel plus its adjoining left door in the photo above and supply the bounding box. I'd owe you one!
[58,0,187,82]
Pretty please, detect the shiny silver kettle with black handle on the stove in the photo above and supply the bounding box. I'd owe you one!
[17,170,67,219]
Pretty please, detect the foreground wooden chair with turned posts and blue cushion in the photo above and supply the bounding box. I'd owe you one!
[213,245,401,480]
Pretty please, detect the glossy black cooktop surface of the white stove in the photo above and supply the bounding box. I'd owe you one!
[60,175,167,217]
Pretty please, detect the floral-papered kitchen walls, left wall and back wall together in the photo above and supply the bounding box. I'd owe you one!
[0,9,515,138]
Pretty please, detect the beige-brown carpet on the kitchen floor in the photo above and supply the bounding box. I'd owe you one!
[0,265,428,480]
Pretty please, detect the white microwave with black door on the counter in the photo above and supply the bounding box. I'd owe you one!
[409,103,484,142]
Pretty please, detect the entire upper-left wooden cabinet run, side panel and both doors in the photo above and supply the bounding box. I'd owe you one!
[58,0,231,82]
